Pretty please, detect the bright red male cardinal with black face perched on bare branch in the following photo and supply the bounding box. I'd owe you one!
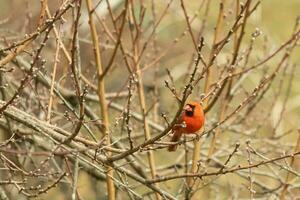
[168,101,205,151]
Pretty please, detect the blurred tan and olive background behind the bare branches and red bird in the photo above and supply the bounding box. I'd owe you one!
[0,0,300,199]
